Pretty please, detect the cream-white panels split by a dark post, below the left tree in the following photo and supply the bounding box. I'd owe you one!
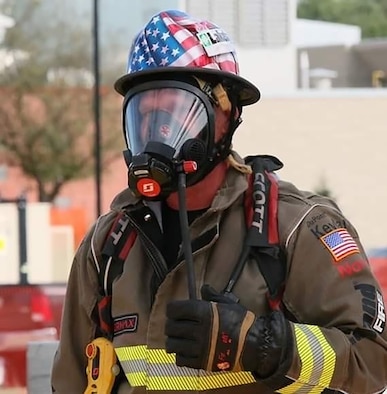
[0,203,74,284]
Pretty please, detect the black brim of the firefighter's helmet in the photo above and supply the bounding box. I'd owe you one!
[114,67,261,106]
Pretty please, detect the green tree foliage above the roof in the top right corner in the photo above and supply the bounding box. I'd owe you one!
[297,0,387,38]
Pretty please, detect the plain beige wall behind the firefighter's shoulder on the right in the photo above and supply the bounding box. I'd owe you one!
[234,89,387,248]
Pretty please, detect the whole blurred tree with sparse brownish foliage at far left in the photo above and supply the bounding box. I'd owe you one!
[0,0,122,201]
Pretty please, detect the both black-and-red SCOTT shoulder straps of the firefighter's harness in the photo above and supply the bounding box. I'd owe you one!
[98,155,286,336]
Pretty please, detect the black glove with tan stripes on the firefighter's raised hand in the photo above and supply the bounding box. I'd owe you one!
[165,285,291,378]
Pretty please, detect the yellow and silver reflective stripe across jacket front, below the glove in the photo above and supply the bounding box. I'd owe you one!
[116,345,255,390]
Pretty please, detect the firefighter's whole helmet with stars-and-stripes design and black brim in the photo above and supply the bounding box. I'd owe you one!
[114,10,260,105]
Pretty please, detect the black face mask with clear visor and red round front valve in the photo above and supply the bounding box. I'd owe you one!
[123,80,216,200]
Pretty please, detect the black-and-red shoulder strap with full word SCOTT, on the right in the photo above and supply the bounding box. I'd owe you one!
[224,155,286,309]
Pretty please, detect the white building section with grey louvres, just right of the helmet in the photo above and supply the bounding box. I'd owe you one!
[183,0,297,94]
